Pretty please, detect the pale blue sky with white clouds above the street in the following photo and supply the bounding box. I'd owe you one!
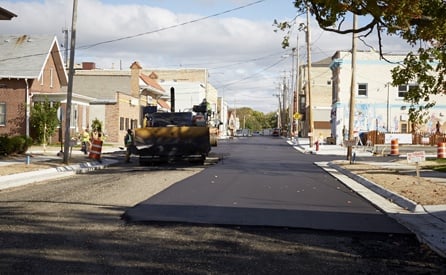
[0,0,407,113]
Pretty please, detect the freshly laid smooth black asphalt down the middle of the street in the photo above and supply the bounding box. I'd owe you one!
[123,136,409,233]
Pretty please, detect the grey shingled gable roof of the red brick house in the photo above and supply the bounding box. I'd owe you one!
[0,35,68,86]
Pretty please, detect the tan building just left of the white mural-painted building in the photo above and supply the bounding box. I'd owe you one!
[296,58,332,141]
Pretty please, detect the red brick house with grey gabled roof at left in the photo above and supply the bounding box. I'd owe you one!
[0,35,91,142]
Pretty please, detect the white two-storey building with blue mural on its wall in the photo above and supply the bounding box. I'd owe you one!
[329,50,446,144]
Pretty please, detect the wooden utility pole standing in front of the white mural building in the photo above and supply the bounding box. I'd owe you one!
[347,14,357,163]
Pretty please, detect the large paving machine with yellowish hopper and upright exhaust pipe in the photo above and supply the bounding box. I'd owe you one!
[131,91,217,165]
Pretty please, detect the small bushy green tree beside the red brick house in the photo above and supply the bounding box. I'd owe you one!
[30,99,60,144]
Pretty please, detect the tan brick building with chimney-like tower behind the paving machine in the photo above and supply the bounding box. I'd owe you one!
[69,61,169,143]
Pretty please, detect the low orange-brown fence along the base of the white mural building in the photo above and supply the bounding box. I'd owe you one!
[360,130,446,146]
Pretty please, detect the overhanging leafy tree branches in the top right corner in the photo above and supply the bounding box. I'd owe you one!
[275,0,446,123]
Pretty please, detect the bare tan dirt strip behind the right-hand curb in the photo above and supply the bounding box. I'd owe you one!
[336,162,446,205]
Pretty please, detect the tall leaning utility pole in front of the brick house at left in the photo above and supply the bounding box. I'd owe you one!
[63,0,77,164]
